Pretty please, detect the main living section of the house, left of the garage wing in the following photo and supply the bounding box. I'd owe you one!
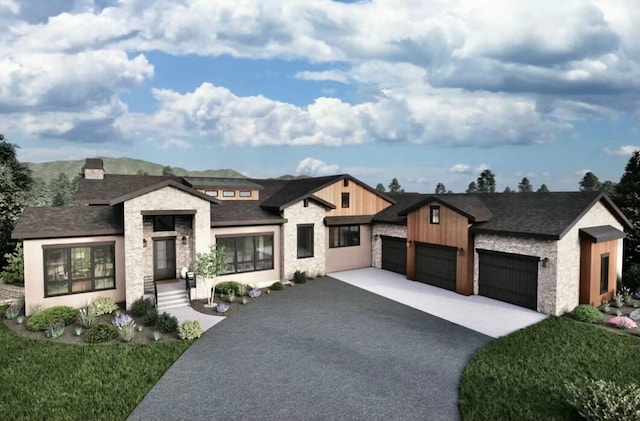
[12,159,394,313]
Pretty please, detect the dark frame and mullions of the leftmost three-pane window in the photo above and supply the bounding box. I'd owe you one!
[42,241,118,298]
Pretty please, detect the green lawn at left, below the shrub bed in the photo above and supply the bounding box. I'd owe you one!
[0,307,191,420]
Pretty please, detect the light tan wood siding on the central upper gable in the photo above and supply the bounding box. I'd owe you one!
[314,180,391,216]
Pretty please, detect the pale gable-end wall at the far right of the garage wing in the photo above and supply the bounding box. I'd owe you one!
[556,202,623,314]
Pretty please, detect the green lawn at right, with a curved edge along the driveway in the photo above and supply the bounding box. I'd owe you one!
[460,317,640,421]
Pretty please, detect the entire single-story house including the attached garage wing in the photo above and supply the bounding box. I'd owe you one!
[13,159,630,314]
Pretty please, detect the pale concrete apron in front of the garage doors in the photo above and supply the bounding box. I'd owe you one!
[329,268,547,338]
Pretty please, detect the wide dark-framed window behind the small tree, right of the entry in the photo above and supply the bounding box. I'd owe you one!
[216,234,273,274]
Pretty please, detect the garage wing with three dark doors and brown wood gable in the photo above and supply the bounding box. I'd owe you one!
[372,192,630,315]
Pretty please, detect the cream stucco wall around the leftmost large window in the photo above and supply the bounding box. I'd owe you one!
[23,236,125,316]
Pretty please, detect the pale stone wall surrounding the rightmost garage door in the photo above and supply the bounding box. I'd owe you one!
[473,234,556,314]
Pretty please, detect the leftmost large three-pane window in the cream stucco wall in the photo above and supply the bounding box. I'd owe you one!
[44,243,116,297]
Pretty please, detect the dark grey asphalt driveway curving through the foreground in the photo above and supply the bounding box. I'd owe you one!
[130,277,491,420]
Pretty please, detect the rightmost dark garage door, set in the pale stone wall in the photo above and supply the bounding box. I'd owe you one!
[478,250,539,310]
